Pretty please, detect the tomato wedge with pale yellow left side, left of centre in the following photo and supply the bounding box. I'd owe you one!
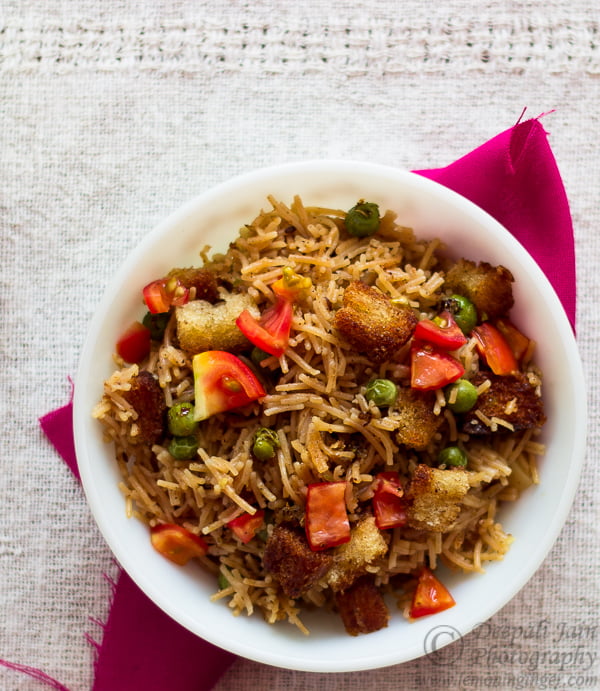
[192,350,265,420]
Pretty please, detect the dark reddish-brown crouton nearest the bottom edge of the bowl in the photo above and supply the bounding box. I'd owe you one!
[335,576,390,636]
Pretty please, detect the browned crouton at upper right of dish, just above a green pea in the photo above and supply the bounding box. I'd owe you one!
[445,259,515,319]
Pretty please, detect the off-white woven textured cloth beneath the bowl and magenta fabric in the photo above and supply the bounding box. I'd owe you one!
[0,0,600,691]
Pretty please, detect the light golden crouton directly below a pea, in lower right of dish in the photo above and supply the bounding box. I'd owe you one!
[404,464,469,533]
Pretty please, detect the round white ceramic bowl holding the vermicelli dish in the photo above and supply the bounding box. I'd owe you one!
[74,161,586,672]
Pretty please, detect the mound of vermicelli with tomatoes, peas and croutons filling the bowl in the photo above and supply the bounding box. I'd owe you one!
[95,198,545,634]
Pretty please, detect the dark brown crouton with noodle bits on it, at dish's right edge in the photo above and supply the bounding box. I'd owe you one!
[463,372,546,434]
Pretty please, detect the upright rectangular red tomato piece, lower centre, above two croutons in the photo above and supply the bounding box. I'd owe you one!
[305,480,350,552]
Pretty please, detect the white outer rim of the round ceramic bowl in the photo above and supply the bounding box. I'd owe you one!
[73,159,587,672]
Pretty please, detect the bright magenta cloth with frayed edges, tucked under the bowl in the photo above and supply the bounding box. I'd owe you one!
[11,113,576,691]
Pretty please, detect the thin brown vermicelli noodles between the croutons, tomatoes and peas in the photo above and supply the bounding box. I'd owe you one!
[94,198,544,632]
